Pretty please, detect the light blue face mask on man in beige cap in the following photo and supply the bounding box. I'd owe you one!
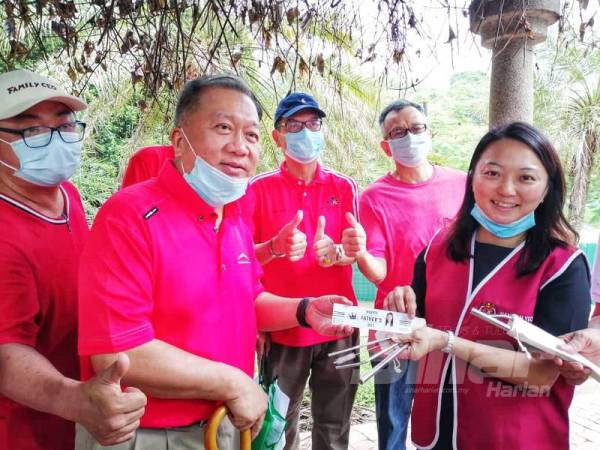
[0,132,82,186]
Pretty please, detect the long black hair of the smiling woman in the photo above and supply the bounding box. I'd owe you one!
[446,122,579,276]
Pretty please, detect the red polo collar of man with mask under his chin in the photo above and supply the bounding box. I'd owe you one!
[157,160,240,218]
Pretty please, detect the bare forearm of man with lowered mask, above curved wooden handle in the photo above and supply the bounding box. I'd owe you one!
[92,339,248,401]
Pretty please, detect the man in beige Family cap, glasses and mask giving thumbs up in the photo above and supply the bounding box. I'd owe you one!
[0,70,146,450]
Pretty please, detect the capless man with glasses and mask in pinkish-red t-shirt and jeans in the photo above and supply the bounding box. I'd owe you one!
[344,100,466,450]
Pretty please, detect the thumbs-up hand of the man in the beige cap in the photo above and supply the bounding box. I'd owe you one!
[74,353,146,445]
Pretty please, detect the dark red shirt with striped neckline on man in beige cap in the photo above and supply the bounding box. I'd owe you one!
[0,183,88,450]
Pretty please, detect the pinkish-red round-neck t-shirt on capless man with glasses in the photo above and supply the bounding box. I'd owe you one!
[360,166,466,308]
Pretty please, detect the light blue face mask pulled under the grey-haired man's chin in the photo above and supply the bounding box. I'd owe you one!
[181,130,248,207]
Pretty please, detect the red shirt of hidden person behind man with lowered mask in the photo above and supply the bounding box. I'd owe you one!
[121,145,175,188]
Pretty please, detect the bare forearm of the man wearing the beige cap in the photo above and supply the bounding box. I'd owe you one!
[0,344,80,420]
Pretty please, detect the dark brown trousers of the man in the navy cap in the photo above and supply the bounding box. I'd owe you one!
[265,333,358,450]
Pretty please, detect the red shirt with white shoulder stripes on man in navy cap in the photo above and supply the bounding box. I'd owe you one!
[249,162,358,347]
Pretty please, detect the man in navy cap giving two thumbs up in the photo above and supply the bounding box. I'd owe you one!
[250,92,358,450]
